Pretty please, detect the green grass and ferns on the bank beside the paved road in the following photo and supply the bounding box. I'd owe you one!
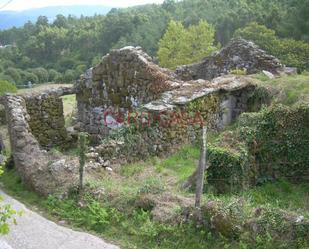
[1,146,309,249]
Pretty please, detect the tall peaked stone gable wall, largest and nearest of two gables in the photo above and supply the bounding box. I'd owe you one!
[76,47,178,135]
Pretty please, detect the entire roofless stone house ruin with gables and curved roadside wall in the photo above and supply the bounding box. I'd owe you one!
[1,40,283,195]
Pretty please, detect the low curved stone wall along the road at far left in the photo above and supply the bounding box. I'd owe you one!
[4,95,76,195]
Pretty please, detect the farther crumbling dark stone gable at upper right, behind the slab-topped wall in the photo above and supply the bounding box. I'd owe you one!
[176,38,283,80]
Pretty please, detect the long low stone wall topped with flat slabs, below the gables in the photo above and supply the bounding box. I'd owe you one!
[85,76,255,167]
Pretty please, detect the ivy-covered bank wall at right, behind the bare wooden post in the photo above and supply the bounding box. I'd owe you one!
[208,104,309,192]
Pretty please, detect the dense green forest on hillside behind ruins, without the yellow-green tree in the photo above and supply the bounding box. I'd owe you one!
[0,0,309,86]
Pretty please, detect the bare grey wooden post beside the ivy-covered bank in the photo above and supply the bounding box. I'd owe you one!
[195,126,207,209]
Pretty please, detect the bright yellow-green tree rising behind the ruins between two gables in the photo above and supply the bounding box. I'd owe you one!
[158,20,216,69]
